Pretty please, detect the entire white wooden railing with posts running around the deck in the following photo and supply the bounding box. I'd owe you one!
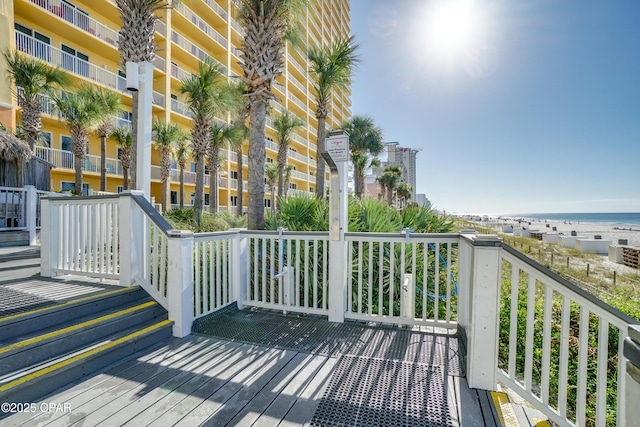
[41,192,640,427]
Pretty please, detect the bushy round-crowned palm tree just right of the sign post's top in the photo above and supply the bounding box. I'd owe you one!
[342,116,384,198]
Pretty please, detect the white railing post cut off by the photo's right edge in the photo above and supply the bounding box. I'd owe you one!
[618,325,640,426]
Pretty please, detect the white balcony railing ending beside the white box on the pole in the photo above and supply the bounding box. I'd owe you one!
[16,32,126,91]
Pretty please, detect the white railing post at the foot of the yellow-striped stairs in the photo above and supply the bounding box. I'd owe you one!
[167,230,194,338]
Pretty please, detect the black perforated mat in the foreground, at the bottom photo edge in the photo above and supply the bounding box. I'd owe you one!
[311,356,453,427]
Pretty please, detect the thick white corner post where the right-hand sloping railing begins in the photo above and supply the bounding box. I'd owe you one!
[458,234,502,390]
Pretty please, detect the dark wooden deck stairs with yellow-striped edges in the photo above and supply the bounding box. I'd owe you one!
[0,287,172,410]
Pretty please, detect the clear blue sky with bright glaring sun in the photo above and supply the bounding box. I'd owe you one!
[351,0,640,213]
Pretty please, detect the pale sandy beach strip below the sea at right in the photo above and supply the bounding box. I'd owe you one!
[482,219,640,247]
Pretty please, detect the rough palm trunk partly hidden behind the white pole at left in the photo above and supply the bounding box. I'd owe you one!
[115,0,171,188]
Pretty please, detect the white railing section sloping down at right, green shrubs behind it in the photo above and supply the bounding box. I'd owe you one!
[498,245,637,426]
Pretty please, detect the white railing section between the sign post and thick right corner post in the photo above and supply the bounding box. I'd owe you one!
[345,233,460,329]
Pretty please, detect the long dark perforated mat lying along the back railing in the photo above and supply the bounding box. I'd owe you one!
[194,309,463,376]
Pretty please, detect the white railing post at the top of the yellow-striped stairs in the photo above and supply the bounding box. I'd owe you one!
[118,190,144,286]
